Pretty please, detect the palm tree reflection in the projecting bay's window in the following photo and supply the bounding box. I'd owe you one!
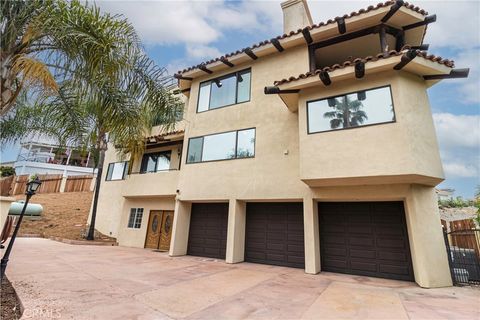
[323,96,368,129]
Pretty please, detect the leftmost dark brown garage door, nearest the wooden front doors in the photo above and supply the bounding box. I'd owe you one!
[187,203,228,259]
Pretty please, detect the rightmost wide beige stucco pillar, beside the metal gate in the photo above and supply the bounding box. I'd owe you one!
[406,185,452,288]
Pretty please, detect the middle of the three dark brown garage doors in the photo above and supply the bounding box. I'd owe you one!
[245,203,305,268]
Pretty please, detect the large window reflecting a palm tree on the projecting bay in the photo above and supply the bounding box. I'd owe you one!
[307,86,395,133]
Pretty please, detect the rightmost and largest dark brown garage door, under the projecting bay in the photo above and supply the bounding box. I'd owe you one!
[318,202,414,281]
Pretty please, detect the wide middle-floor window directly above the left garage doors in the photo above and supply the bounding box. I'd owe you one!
[187,129,255,163]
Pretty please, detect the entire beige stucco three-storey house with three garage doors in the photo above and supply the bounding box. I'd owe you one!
[96,0,463,287]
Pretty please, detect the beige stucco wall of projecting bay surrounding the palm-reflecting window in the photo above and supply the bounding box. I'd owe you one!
[298,70,443,186]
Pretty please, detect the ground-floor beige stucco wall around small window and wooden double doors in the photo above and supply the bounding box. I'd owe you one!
[117,197,175,248]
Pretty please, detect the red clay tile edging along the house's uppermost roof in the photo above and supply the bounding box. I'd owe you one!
[177,0,428,75]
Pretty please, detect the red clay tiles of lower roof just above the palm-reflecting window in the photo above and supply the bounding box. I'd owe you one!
[273,46,454,86]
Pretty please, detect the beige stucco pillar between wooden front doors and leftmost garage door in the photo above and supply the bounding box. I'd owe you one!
[169,200,192,257]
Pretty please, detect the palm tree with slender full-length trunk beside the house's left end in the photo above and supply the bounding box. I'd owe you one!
[0,2,182,240]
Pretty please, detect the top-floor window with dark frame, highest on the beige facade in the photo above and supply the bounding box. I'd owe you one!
[197,69,251,112]
